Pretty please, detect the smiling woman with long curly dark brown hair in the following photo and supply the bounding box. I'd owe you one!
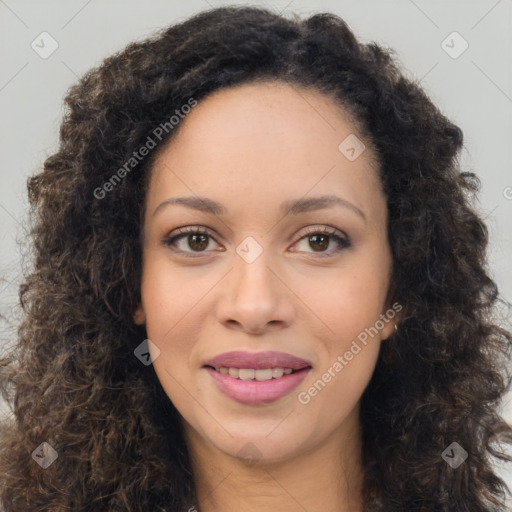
[0,7,512,512]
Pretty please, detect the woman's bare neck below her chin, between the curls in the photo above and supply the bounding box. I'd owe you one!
[187,410,363,512]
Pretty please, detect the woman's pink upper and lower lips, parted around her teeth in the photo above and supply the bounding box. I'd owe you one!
[203,351,311,405]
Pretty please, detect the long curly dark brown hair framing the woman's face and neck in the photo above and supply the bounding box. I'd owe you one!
[0,7,512,512]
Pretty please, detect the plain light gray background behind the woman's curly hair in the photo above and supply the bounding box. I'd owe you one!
[0,0,512,509]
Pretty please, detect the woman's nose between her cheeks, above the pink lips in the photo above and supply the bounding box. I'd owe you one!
[217,250,296,335]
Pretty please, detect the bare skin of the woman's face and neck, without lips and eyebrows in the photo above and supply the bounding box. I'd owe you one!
[134,83,396,512]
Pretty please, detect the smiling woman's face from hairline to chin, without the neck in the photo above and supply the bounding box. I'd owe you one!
[134,83,395,461]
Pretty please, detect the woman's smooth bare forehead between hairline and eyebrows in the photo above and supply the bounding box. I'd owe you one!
[149,82,382,222]
